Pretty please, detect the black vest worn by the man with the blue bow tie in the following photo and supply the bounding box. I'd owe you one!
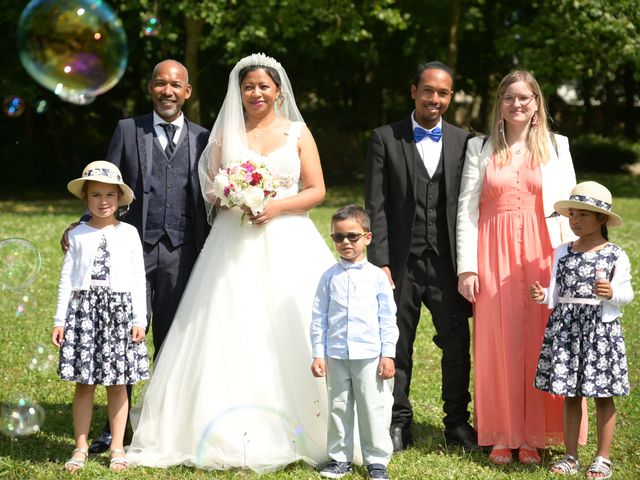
[410,152,449,257]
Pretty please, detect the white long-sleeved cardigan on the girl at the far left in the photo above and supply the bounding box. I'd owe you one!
[54,222,147,328]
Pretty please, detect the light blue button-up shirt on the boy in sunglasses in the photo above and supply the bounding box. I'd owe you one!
[310,259,398,360]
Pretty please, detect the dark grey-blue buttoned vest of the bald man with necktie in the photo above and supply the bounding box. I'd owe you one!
[144,123,194,247]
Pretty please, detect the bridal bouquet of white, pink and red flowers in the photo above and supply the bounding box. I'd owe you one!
[213,160,278,218]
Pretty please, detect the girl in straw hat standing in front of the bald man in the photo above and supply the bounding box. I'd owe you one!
[51,161,149,473]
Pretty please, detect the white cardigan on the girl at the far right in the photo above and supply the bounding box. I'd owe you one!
[539,243,633,323]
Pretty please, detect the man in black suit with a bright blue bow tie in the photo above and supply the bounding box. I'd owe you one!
[365,62,478,451]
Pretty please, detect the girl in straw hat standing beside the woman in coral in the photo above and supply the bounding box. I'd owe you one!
[530,182,633,478]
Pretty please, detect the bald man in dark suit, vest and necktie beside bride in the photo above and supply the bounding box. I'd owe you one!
[89,60,209,453]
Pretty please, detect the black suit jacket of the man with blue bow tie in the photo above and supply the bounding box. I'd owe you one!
[364,116,473,279]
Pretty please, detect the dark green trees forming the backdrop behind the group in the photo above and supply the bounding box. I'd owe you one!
[0,0,640,197]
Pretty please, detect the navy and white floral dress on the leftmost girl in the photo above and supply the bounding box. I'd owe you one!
[58,236,149,385]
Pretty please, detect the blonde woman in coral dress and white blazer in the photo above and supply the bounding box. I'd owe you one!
[457,71,576,464]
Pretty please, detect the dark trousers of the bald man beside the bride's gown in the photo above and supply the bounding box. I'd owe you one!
[103,235,198,432]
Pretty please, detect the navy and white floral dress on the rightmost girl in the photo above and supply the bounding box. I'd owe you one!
[535,243,629,398]
